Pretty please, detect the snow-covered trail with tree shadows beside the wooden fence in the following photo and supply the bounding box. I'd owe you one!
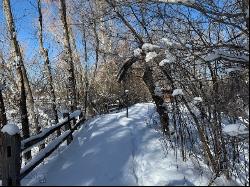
[22,104,234,186]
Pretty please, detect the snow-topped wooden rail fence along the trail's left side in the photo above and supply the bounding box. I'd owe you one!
[0,111,85,186]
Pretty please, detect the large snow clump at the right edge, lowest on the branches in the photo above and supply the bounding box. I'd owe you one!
[222,123,249,136]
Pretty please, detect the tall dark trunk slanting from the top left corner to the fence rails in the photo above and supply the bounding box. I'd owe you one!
[3,0,31,160]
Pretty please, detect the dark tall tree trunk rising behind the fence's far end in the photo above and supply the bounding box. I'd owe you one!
[59,0,77,111]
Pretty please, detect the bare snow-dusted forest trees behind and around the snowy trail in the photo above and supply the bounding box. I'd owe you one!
[0,0,249,185]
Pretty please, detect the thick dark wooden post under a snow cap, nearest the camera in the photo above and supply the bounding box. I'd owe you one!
[0,132,21,186]
